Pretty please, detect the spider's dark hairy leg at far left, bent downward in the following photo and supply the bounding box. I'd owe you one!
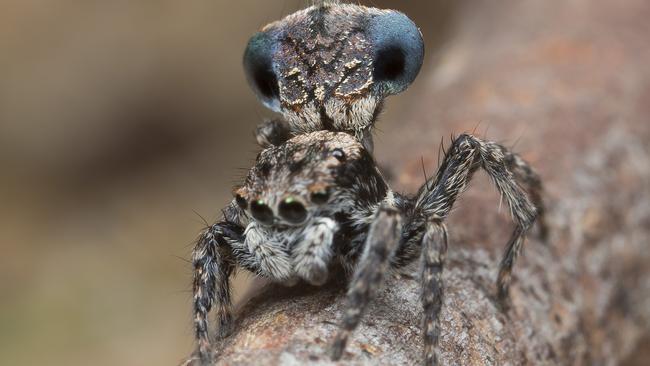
[192,222,242,364]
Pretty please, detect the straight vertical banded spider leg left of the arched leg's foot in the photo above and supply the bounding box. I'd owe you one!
[421,219,447,365]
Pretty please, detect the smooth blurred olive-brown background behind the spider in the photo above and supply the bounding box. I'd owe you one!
[0,0,457,365]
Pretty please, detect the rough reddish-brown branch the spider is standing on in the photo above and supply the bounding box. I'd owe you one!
[202,0,650,365]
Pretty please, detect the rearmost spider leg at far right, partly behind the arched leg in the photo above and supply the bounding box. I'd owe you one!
[497,149,548,240]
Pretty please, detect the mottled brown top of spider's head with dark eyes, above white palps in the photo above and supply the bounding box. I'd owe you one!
[235,131,378,227]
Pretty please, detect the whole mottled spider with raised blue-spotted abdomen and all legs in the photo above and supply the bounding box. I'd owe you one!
[186,1,545,365]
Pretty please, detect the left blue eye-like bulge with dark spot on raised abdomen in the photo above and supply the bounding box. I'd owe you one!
[244,32,280,111]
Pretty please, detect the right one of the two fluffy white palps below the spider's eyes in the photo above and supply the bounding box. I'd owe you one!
[293,218,338,286]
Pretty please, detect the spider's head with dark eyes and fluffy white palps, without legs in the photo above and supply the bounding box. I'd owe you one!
[233,131,388,285]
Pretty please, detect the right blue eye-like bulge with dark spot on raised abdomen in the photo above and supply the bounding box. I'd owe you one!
[368,12,424,94]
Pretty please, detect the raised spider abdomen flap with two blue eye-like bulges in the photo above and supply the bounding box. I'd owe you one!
[244,3,424,132]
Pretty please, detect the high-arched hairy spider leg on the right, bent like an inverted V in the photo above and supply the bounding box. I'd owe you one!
[416,134,537,300]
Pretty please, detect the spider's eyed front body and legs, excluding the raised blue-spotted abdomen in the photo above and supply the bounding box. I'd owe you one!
[193,131,541,364]
